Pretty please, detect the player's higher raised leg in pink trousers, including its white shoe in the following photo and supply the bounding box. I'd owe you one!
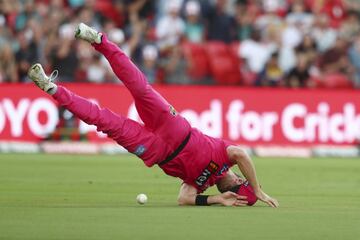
[76,24,190,150]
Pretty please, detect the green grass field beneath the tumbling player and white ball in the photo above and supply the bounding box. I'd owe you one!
[0,154,360,240]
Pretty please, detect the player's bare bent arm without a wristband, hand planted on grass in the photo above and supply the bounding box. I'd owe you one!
[227,146,279,207]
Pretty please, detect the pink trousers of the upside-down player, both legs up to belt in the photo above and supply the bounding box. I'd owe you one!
[53,35,191,166]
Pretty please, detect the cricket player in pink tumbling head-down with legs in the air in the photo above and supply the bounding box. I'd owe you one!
[28,23,279,207]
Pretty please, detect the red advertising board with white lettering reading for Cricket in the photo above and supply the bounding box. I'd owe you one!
[0,84,360,146]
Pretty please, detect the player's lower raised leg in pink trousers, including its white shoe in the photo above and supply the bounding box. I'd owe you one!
[29,64,160,164]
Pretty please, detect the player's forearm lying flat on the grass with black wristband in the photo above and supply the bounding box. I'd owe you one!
[178,183,247,206]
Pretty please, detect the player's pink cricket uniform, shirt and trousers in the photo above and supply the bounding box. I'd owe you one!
[53,35,233,193]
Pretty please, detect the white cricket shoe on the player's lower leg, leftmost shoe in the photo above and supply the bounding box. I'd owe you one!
[28,63,58,94]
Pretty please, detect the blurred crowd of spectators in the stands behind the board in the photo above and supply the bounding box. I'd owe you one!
[0,0,360,88]
